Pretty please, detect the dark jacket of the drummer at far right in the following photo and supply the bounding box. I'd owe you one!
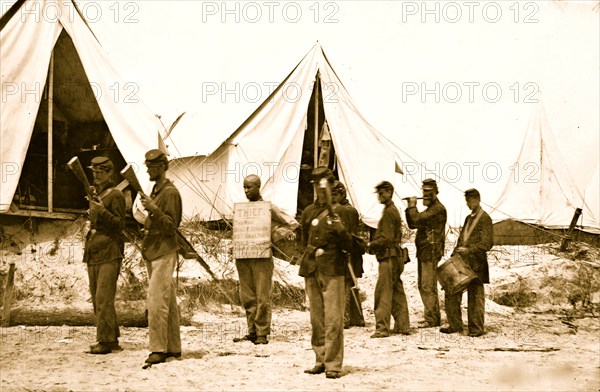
[453,207,494,283]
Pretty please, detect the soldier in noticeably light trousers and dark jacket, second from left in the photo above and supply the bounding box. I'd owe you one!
[141,150,182,364]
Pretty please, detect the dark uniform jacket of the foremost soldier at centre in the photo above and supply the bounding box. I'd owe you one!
[298,202,352,277]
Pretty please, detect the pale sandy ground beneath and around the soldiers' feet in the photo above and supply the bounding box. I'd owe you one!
[0,222,600,392]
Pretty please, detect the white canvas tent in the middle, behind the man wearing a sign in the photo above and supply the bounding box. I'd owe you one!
[169,43,415,227]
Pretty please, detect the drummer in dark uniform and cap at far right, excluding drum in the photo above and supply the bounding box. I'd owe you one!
[440,189,494,337]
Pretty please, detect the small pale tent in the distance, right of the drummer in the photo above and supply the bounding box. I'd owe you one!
[490,100,600,237]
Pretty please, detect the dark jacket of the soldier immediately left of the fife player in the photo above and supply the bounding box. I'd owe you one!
[370,201,402,261]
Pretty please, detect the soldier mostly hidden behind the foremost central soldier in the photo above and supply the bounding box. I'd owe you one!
[331,181,365,329]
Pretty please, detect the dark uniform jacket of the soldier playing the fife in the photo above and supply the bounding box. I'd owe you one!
[406,199,447,261]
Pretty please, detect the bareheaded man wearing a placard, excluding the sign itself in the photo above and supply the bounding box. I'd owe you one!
[233,174,298,344]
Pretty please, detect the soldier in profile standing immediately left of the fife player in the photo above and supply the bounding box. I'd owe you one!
[366,181,410,338]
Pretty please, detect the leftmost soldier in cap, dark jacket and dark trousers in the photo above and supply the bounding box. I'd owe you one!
[83,157,125,354]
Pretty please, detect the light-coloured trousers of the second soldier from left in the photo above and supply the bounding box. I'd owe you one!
[146,252,181,353]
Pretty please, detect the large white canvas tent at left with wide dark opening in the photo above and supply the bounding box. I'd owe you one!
[0,0,161,213]
